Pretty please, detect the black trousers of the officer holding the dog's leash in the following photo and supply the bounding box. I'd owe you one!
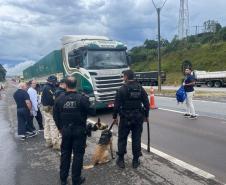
[117,112,144,158]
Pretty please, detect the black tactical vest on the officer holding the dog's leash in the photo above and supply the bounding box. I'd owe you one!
[122,83,142,110]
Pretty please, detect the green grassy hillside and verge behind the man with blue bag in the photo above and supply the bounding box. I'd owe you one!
[131,42,226,85]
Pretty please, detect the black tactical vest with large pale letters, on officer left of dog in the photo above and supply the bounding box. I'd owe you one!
[60,93,83,126]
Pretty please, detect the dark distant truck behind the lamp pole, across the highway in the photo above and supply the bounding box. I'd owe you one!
[135,71,166,86]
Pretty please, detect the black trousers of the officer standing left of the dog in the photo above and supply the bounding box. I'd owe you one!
[60,125,86,185]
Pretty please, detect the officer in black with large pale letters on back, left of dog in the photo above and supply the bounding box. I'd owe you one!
[53,77,90,185]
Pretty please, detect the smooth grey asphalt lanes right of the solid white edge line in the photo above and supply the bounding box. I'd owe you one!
[91,97,226,183]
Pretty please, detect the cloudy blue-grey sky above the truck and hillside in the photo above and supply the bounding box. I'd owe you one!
[0,0,226,74]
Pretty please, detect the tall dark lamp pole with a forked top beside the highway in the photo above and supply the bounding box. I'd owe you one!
[152,0,167,92]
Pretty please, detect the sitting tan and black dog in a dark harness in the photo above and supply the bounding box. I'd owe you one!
[83,118,115,169]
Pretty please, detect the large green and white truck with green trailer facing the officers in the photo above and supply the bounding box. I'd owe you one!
[23,35,130,109]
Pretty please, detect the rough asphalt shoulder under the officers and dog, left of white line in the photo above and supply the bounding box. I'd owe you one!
[0,82,222,185]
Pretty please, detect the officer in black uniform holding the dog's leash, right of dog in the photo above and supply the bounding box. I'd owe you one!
[113,70,149,168]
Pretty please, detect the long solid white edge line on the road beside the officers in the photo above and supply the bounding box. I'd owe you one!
[87,118,215,179]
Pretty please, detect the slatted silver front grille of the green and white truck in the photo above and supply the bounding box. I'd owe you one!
[95,76,123,102]
